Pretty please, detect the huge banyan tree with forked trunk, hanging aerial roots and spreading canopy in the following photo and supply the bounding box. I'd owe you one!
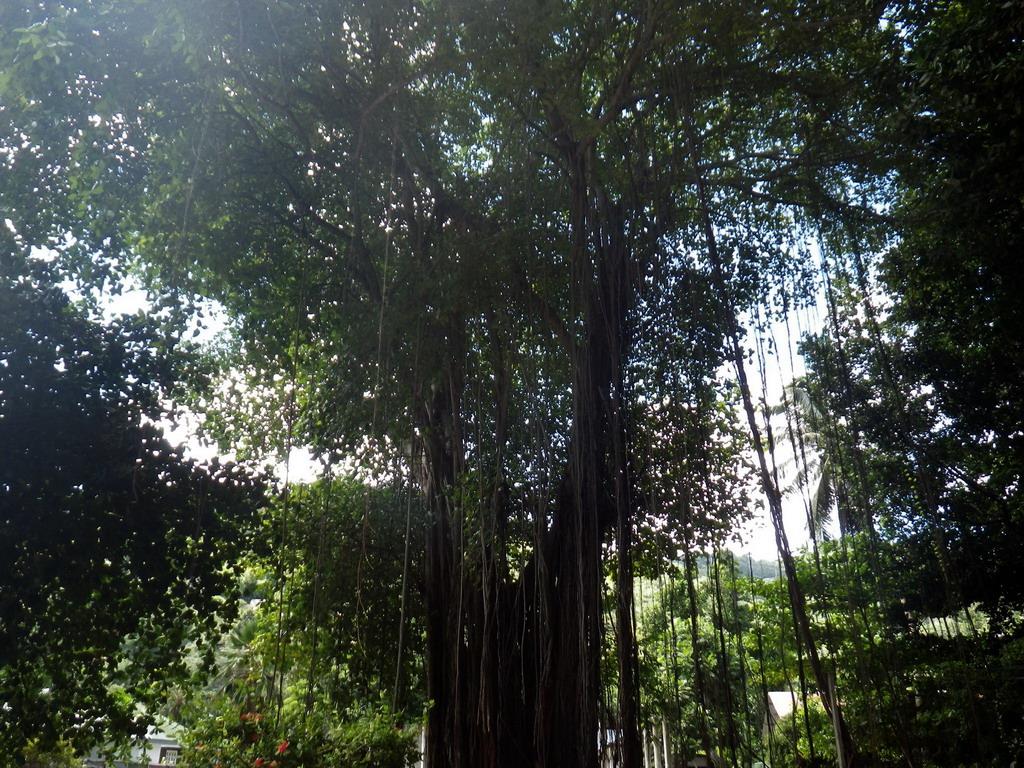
[3,0,1019,768]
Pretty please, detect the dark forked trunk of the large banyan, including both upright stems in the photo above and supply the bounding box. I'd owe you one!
[421,153,642,768]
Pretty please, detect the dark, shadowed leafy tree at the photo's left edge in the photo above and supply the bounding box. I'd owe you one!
[0,251,262,755]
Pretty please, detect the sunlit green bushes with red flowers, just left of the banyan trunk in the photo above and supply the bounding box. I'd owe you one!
[170,480,424,768]
